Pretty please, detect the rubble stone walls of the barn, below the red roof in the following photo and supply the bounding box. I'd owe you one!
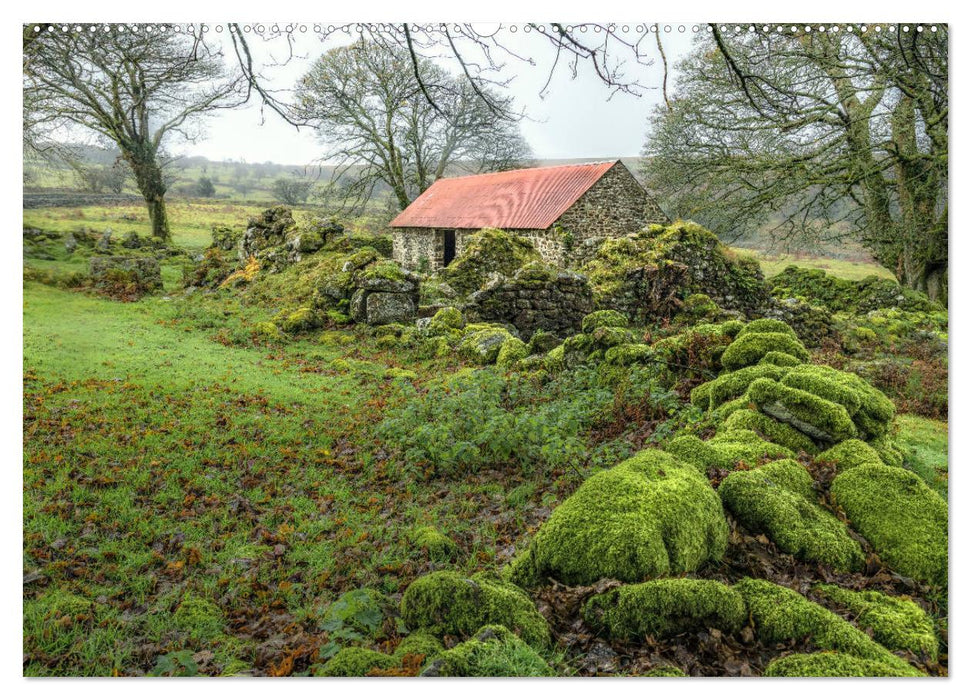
[392,163,669,272]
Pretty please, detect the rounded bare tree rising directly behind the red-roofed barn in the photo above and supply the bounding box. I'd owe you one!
[295,41,528,208]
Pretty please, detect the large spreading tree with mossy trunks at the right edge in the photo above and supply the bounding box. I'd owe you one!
[645,26,948,303]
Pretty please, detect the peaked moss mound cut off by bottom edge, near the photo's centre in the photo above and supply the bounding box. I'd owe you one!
[422,625,556,678]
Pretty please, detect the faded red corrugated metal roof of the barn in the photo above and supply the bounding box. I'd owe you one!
[391,160,620,229]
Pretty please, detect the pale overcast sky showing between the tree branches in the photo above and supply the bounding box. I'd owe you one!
[171,24,693,165]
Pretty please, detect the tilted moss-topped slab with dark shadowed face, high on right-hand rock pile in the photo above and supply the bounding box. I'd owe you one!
[746,379,857,443]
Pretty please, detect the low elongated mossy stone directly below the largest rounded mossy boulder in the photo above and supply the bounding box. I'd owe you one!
[583,578,745,641]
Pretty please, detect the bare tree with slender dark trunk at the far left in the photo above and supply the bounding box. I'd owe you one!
[24,25,246,239]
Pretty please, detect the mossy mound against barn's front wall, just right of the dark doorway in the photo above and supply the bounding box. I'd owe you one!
[441,228,541,295]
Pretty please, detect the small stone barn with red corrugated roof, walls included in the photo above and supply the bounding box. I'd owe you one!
[391,160,669,271]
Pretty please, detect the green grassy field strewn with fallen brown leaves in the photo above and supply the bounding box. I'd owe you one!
[23,204,947,675]
